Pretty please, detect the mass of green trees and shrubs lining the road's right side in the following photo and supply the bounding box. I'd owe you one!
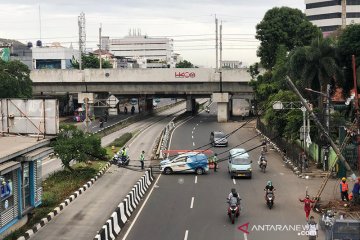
[249,7,360,144]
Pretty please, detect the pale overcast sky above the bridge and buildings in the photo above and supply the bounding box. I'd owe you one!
[0,0,305,67]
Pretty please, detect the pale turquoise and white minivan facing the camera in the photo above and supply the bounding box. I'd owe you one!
[228,148,252,178]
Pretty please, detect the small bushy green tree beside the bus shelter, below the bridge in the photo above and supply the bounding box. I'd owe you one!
[53,125,106,171]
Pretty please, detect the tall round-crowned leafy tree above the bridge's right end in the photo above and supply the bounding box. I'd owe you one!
[256,7,321,70]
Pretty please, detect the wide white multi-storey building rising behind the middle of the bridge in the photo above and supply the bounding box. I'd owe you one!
[102,33,178,68]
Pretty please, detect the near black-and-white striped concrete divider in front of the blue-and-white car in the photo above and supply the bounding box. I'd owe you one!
[94,169,154,240]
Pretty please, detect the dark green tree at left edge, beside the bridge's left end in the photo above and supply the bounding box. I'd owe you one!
[0,60,32,98]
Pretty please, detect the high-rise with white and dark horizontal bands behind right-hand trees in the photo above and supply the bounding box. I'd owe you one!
[305,0,360,34]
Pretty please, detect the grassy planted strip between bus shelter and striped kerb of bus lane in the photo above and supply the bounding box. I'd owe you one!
[4,161,107,240]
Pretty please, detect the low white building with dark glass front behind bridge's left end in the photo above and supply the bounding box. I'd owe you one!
[32,43,79,69]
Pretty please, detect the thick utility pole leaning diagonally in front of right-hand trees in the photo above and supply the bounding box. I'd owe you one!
[286,76,356,179]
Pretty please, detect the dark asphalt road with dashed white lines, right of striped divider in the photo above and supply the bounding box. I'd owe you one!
[117,103,333,240]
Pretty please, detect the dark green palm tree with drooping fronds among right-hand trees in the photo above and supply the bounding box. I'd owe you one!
[289,38,342,109]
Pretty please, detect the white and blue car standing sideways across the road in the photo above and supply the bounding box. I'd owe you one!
[160,152,209,175]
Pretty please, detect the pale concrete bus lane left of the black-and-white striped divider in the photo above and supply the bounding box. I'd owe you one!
[30,102,184,240]
